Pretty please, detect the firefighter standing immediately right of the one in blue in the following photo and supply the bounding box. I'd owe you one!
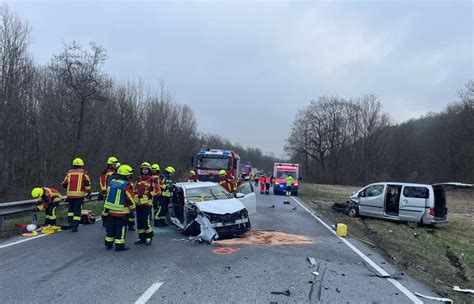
[133,162,153,245]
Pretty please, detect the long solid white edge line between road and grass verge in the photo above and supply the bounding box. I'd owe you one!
[291,196,423,304]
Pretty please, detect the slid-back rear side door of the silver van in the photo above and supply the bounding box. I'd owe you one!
[398,185,430,223]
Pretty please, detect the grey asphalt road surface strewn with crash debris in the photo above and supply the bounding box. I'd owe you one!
[0,189,433,303]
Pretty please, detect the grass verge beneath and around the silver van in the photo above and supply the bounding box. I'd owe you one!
[300,184,474,303]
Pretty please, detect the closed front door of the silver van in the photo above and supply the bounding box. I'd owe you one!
[359,184,386,217]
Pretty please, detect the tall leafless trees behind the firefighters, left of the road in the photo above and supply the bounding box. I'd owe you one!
[0,6,278,201]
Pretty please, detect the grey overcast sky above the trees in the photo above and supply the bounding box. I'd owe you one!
[8,0,474,155]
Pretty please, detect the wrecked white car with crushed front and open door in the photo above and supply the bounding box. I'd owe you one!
[170,182,257,237]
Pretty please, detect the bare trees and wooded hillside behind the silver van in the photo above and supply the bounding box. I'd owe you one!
[285,81,474,184]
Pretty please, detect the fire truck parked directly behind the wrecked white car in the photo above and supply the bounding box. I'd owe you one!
[195,149,241,182]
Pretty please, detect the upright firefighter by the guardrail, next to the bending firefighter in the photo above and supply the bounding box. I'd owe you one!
[63,158,91,232]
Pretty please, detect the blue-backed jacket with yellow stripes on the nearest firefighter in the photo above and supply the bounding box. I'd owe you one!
[104,178,135,217]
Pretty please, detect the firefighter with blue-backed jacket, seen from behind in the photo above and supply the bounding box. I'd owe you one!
[104,165,135,251]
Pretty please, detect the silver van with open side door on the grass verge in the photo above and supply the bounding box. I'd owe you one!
[346,182,472,226]
